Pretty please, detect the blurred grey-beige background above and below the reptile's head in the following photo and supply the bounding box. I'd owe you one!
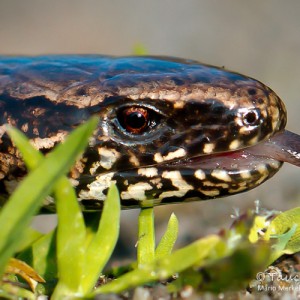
[0,0,300,255]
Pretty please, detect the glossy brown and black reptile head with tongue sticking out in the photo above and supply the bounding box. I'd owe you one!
[0,55,300,210]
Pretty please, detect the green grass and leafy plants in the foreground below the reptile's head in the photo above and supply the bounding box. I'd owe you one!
[0,119,300,299]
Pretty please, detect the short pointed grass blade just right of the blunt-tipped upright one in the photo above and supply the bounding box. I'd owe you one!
[155,214,178,259]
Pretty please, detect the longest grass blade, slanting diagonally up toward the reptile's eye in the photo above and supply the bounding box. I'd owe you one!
[0,119,98,273]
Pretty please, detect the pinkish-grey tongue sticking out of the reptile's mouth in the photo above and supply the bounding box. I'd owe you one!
[246,130,300,167]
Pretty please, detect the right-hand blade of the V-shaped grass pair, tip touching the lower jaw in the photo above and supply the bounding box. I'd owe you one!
[81,185,121,293]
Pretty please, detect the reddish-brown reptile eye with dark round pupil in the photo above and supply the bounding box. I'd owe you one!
[117,106,158,134]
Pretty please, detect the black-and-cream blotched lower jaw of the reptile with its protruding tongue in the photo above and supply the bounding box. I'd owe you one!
[79,131,300,206]
